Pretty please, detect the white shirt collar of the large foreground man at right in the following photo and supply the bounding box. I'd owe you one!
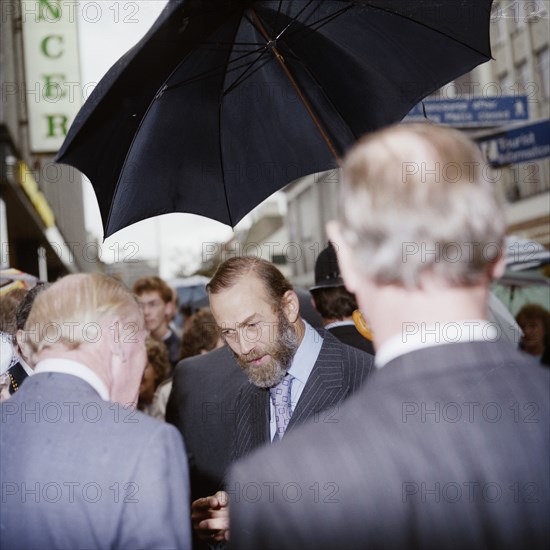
[374,319,499,368]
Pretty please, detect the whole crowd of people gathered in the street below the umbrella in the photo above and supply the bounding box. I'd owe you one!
[0,124,550,550]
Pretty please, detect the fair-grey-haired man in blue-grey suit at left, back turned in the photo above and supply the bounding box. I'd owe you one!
[0,274,191,550]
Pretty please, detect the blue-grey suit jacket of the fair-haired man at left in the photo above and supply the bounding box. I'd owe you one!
[0,373,191,550]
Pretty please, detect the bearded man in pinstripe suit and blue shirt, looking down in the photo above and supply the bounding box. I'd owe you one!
[187,257,373,542]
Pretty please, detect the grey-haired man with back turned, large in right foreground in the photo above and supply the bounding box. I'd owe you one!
[229,124,550,549]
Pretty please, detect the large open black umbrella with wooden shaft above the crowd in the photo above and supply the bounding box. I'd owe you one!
[57,0,492,236]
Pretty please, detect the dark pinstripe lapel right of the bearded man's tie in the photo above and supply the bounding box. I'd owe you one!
[287,334,349,431]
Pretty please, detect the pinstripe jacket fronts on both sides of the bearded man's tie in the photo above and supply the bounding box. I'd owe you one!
[233,329,373,460]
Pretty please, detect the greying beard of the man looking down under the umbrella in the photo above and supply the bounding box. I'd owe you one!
[234,311,298,388]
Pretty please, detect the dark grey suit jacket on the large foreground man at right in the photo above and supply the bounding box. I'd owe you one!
[230,342,550,549]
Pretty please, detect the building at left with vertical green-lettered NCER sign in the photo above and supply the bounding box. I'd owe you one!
[0,0,90,280]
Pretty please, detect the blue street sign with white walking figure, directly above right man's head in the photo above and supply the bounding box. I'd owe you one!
[404,95,529,128]
